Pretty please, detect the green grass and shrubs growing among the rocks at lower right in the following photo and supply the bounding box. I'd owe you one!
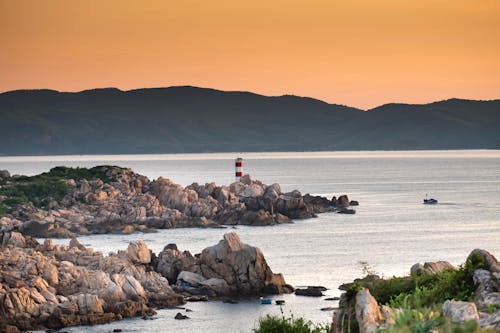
[342,254,487,333]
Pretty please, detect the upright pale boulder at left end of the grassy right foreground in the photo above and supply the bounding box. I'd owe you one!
[356,288,384,333]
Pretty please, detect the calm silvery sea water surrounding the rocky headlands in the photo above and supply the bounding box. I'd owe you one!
[0,151,500,332]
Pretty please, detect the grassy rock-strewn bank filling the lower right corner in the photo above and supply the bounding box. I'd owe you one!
[331,249,500,333]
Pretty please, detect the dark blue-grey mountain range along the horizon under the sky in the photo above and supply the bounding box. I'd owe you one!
[0,87,500,155]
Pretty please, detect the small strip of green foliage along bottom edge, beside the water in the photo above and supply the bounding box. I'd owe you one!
[254,315,330,333]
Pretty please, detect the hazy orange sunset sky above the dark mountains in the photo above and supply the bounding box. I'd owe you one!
[0,0,500,108]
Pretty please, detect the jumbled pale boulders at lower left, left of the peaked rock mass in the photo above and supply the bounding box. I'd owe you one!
[0,232,185,331]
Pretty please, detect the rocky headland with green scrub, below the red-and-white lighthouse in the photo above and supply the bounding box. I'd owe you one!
[0,166,358,238]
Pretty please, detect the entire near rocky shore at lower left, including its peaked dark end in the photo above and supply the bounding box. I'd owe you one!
[0,232,293,332]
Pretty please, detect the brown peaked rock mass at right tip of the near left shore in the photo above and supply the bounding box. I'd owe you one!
[156,232,293,297]
